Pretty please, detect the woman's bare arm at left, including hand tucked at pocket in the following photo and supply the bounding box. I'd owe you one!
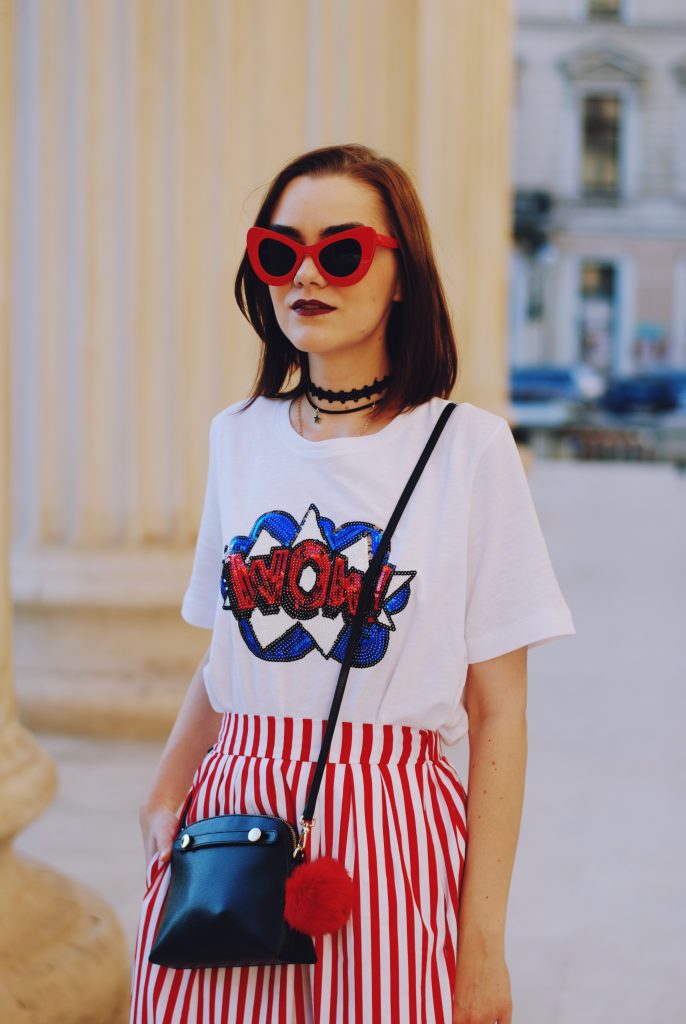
[139,647,222,861]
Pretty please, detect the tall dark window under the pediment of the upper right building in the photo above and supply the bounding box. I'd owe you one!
[582,93,621,199]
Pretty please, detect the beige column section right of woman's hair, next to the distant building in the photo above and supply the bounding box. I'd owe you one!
[417,0,514,415]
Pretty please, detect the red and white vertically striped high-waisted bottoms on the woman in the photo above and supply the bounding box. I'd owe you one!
[130,714,467,1024]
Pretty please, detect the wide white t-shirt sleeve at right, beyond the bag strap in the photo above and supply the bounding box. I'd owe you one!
[465,419,576,664]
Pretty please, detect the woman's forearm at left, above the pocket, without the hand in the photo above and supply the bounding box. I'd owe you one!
[143,648,221,811]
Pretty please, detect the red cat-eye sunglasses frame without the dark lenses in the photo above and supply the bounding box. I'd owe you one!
[248,226,400,286]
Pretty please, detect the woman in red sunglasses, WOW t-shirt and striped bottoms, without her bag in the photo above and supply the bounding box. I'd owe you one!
[131,145,574,1024]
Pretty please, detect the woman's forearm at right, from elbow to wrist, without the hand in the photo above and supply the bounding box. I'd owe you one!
[459,710,527,951]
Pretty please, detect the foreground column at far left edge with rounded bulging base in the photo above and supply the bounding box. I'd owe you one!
[0,0,128,1024]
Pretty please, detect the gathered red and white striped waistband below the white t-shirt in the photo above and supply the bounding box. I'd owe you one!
[214,712,442,764]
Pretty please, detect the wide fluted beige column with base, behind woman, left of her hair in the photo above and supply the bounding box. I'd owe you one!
[12,0,308,735]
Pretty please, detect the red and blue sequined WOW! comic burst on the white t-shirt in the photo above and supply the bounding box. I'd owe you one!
[221,505,417,668]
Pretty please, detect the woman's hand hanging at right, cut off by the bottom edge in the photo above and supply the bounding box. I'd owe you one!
[453,941,512,1024]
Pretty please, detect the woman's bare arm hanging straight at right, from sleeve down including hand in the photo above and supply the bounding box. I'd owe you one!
[454,647,527,1024]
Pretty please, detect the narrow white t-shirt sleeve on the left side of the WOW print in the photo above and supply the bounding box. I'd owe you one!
[181,417,223,630]
